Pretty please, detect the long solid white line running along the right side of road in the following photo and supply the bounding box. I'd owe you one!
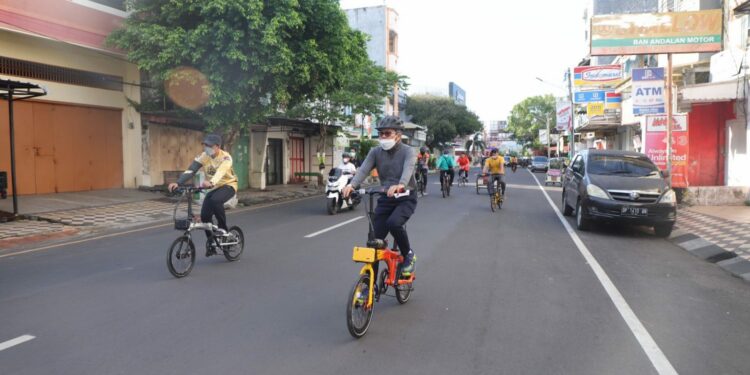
[529,172,677,374]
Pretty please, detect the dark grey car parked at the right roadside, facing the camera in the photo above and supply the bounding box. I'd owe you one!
[562,150,677,237]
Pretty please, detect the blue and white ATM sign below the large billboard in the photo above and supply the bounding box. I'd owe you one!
[633,68,665,116]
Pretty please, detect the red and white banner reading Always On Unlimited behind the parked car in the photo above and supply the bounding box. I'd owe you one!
[644,115,689,187]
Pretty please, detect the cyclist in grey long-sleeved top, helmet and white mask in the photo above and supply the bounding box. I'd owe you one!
[343,116,417,277]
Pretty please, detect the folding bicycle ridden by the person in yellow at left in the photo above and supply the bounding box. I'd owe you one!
[167,187,245,278]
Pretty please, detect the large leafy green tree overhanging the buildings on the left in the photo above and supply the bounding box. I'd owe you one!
[108,0,374,148]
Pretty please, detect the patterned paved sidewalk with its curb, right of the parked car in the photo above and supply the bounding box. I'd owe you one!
[670,206,750,281]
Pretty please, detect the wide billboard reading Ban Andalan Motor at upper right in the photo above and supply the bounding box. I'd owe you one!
[590,9,723,56]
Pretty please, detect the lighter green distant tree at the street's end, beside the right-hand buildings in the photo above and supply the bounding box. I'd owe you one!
[508,95,555,144]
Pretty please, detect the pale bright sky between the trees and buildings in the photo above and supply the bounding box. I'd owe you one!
[340,0,587,126]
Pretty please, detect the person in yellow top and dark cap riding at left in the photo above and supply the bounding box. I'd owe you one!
[169,134,237,256]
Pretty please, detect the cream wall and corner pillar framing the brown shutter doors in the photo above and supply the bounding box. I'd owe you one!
[0,30,144,188]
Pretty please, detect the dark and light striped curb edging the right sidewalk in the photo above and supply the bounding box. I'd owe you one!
[669,229,750,281]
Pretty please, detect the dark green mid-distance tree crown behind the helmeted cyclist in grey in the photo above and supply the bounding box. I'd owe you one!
[405,95,482,148]
